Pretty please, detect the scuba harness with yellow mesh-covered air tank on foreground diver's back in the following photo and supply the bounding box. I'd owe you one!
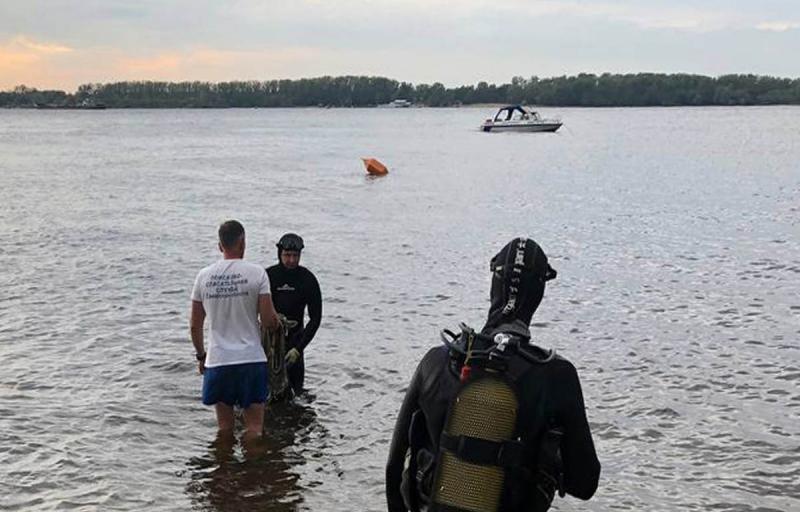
[403,323,564,512]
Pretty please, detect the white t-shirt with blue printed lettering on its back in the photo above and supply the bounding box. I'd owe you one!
[192,259,269,368]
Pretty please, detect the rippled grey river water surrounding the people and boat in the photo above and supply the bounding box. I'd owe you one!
[0,107,800,511]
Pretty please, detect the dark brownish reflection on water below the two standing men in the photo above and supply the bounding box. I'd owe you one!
[186,395,324,512]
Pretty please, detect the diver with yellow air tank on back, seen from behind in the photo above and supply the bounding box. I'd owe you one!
[386,238,600,512]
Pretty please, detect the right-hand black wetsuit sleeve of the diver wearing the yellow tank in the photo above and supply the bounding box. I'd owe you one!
[560,365,600,500]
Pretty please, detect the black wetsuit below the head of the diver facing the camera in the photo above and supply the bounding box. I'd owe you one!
[267,263,322,393]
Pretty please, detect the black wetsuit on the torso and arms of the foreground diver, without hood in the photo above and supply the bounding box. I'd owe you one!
[386,338,600,512]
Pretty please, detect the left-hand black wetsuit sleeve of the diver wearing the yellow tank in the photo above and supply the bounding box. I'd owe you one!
[386,364,422,512]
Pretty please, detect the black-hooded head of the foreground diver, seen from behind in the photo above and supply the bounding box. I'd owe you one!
[484,238,556,331]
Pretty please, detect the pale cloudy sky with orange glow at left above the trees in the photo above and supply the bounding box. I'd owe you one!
[0,0,800,91]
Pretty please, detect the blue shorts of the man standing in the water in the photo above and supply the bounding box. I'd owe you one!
[203,363,269,409]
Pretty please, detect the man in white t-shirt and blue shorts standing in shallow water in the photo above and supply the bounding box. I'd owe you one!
[190,220,278,437]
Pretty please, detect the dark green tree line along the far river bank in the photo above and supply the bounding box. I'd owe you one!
[0,73,800,108]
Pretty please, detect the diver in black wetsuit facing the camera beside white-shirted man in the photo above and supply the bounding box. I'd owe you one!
[267,233,322,394]
